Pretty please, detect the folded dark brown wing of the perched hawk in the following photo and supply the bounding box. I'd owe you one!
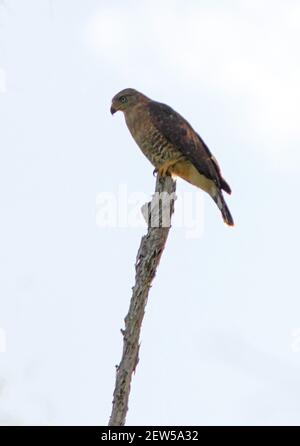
[148,101,231,194]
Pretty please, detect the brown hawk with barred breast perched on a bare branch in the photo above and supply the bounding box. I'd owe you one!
[110,88,234,226]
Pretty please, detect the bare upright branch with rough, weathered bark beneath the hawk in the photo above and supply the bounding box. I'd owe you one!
[109,177,176,426]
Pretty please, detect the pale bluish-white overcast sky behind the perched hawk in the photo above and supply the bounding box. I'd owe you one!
[0,0,300,425]
